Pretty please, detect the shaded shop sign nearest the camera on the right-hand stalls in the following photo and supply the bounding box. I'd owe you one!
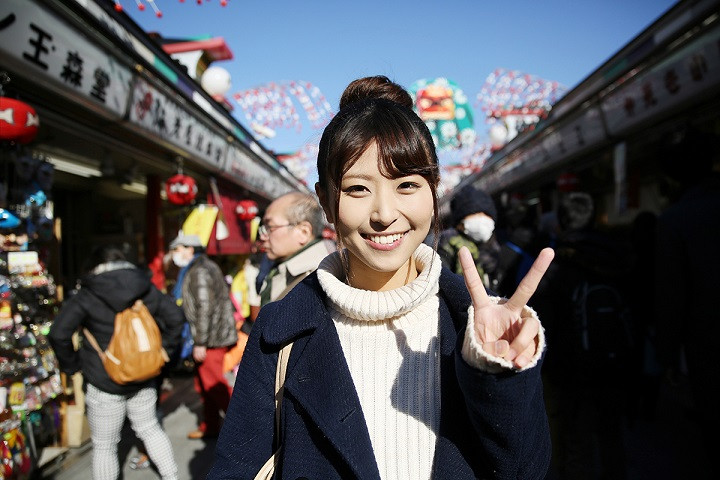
[602,21,720,135]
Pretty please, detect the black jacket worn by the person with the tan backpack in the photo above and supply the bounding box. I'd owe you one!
[49,262,184,394]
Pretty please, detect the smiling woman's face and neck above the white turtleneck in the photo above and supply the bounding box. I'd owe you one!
[329,143,433,290]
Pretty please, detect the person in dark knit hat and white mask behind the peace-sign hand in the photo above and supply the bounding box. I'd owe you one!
[438,185,501,290]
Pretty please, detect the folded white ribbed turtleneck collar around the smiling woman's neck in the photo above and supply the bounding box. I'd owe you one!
[317,243,442,321]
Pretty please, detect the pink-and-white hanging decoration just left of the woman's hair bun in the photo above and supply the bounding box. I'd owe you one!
[232,81,334,136]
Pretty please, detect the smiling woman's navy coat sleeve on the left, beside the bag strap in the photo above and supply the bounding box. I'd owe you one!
[207,304,277,480]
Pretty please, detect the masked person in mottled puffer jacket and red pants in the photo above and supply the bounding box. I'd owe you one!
[170,233,237,439]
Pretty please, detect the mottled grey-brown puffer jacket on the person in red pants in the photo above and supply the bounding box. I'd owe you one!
[182,254,237,348]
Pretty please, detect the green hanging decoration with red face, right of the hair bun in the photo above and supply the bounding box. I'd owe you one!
[410,77,476,149]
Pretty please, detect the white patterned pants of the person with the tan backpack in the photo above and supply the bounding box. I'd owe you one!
[85,384,178,480]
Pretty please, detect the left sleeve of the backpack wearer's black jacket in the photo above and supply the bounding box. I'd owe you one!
[48,293,87,375]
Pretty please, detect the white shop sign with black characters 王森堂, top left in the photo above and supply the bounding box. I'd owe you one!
[0,0,132,117]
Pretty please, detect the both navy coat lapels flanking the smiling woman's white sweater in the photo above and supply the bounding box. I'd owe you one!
[265,268,470,479]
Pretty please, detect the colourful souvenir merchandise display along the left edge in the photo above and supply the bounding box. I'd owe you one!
[0,249,63,480]
